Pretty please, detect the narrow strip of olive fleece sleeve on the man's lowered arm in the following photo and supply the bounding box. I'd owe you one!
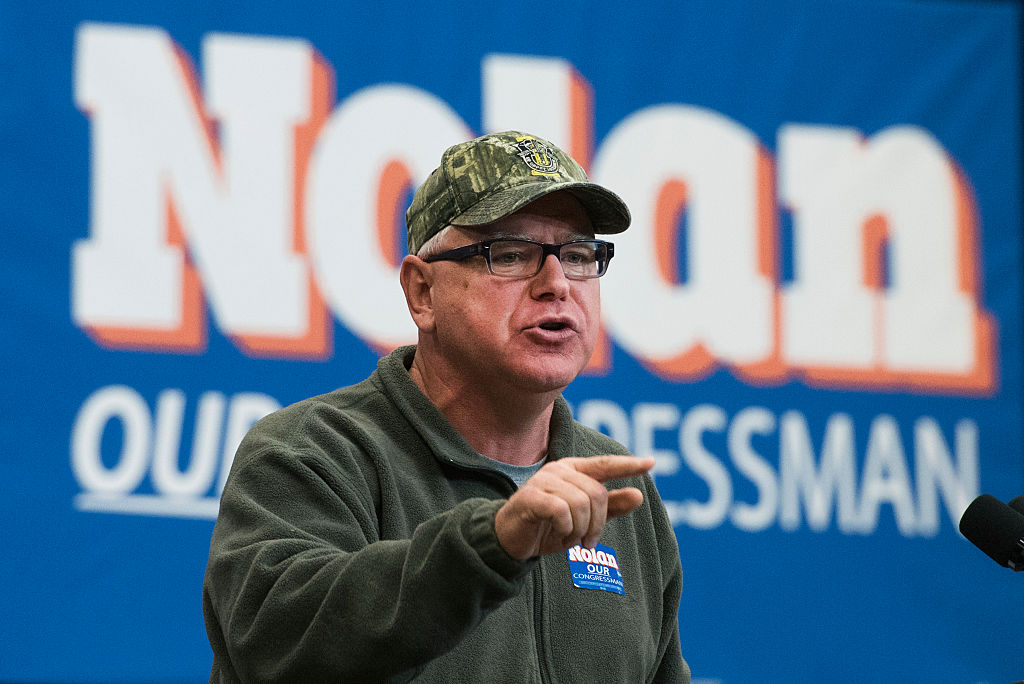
[644,478,690,684]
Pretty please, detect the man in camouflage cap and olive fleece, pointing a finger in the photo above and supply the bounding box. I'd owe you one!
[203,131,689,683]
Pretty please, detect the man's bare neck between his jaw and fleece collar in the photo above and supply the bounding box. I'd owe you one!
[409,352,559,466]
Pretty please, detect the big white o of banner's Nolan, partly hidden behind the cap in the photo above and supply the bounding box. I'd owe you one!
[307,85,472,350]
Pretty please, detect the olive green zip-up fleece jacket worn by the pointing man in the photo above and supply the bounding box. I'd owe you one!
[203,347,689,684]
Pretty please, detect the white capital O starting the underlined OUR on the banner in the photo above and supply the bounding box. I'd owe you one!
[71,385,153,495]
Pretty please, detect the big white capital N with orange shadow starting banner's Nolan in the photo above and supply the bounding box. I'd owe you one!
[73,24,328,355]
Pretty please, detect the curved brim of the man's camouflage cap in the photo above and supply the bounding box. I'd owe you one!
[451,181,631,234]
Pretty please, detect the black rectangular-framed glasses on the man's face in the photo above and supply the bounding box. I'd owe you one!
[423,238,615,280]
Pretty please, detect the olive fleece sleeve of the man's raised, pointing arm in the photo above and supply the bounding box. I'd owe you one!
[203,451,532,682]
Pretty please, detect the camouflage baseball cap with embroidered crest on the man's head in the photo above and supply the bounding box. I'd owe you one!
[406,131,630,254]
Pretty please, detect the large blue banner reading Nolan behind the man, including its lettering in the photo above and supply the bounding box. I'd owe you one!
[0,0,1024,684]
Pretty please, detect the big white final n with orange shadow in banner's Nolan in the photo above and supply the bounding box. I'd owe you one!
[778,125,994,390]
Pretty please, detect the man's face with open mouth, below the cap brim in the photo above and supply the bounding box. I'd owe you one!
[423,193,600,392]
